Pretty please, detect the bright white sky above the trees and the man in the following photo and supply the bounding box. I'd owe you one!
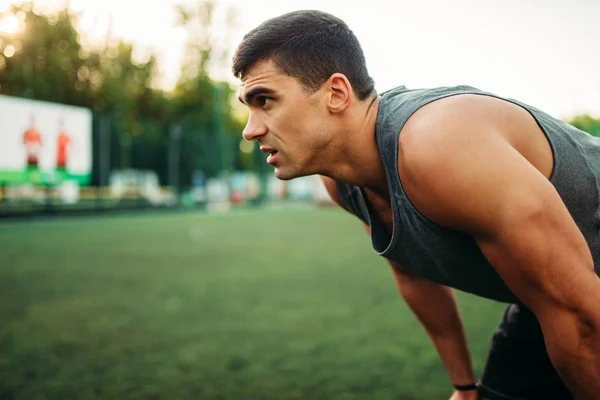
[0,0,600,118]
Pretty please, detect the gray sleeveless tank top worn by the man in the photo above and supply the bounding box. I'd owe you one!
[337,86,600,303]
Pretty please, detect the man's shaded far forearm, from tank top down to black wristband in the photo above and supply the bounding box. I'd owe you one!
[395,264,475,385]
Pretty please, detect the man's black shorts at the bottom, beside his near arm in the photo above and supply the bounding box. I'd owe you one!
[480,304,573,400]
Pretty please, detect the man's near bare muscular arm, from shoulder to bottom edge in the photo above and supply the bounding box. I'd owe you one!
[399,97,600,399]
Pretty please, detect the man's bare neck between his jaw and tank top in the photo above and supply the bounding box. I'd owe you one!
[321,96,388,196]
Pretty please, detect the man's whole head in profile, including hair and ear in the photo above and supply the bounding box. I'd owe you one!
[232,11,375,179]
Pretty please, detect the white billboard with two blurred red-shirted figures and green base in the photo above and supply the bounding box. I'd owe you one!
[0,95,92,185]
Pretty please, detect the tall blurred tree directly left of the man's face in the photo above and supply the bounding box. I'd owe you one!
[172,0,243,181]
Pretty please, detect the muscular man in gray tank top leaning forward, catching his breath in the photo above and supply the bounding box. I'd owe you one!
[233,11,600,399]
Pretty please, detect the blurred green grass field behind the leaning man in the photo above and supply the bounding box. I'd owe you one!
[0,207,503,400]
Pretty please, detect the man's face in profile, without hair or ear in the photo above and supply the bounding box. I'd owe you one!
[240,60,331,180]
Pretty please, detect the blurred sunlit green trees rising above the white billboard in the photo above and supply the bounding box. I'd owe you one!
[0,3,170,119]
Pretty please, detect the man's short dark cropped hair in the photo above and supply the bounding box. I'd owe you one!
[232,10,375,100]
